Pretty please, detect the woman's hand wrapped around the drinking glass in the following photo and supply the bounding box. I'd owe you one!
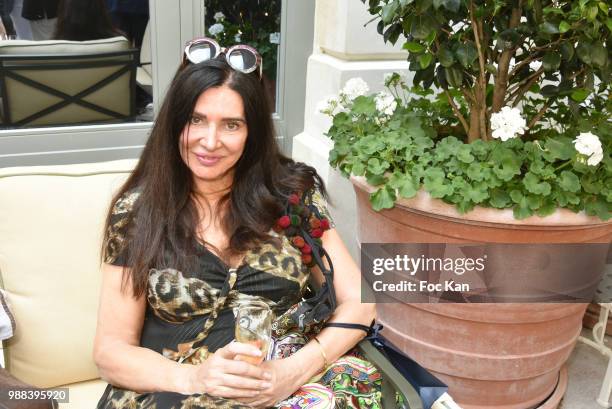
[184,342,273,400]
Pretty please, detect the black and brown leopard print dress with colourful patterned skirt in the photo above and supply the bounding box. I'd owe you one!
[97,191,380,409]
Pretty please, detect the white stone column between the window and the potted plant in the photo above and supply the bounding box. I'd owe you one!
[292,0,408,263]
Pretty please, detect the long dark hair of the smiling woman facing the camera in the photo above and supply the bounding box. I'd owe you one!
[102,57,326,297]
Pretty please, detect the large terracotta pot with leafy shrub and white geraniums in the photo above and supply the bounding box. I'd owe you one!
[319,0,612,408]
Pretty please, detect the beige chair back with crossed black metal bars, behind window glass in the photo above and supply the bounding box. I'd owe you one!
[0,45,138,128]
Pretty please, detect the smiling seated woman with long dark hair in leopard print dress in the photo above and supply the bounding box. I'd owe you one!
[94,40,380,409]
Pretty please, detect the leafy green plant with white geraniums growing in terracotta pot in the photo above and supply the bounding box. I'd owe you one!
[319,0,612,220]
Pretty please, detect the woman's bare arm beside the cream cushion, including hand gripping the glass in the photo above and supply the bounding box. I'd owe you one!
[94,264,269,397]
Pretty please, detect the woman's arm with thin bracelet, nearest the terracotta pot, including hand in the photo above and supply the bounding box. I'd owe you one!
[246,229,376,407]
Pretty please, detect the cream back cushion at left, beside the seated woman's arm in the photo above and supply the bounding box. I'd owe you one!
[0,160,135,386]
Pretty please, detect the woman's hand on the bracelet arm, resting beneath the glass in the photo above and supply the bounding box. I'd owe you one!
[237,358,302,408]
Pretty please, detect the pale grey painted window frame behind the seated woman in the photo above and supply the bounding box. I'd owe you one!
[0,0,314,167]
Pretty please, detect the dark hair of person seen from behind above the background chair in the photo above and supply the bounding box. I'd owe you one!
[53,0,123,41]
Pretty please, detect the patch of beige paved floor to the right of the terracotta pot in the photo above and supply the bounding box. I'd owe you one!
[559,330,612,409]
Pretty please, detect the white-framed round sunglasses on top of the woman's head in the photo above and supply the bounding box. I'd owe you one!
[182,37,262,79]
